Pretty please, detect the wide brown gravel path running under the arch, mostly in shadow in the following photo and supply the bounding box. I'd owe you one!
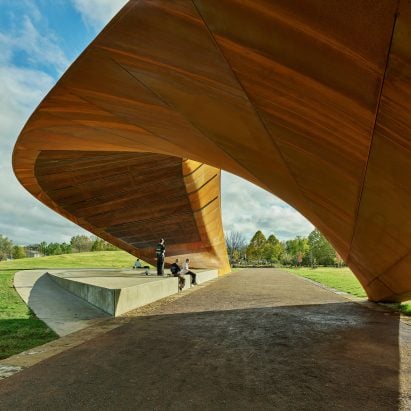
[0,269,411,410]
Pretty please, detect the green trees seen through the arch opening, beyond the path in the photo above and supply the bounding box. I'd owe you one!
[225,229,344,267]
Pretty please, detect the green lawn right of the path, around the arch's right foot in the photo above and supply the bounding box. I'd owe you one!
[285,267,411,316]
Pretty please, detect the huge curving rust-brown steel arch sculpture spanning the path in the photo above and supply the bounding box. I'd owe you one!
[13,0,411,300]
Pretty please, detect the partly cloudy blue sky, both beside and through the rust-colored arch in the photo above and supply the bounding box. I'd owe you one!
[0,0,313,244]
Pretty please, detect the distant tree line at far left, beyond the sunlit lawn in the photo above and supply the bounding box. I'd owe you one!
[0,234,118,261]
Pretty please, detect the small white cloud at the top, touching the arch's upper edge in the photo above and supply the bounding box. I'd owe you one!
[72,0,128,30]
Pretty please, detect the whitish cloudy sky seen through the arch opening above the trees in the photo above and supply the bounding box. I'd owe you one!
[221,172,314,240]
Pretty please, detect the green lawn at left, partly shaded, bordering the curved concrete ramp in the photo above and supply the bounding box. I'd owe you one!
[0,251,143,359]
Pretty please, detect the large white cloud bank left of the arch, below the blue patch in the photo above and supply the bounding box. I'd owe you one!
[0,64,90,244]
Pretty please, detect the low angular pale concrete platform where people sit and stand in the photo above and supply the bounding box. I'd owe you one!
[47,269,218,316]
